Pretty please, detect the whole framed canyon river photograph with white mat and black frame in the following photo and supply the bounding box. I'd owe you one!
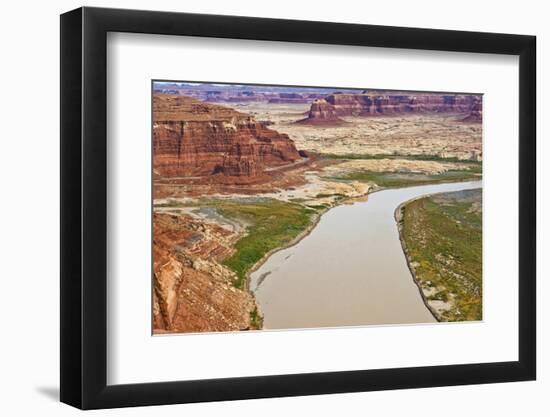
[60,7,536,409]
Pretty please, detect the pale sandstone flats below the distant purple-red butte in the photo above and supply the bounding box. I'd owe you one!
[238,103,482,161]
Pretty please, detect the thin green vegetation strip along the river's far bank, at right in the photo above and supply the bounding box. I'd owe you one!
[335,167,481,188]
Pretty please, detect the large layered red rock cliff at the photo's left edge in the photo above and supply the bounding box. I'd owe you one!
[153,94,301,182]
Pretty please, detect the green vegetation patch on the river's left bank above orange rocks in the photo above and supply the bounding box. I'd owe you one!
[218,199,316,288]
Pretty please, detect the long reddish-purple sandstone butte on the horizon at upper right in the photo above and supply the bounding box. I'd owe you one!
[297,93,482,125]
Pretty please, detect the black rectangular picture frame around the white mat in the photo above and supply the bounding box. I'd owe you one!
[60,7,536,409]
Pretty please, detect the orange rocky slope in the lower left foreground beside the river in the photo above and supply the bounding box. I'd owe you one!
[153,213,257,333]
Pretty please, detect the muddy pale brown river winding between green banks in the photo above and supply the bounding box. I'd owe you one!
[250,181,481,329]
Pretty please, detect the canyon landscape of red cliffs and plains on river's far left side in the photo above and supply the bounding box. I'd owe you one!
[152,83,482,334]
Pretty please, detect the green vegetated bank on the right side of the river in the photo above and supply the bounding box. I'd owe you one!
[401,190,482,321]
